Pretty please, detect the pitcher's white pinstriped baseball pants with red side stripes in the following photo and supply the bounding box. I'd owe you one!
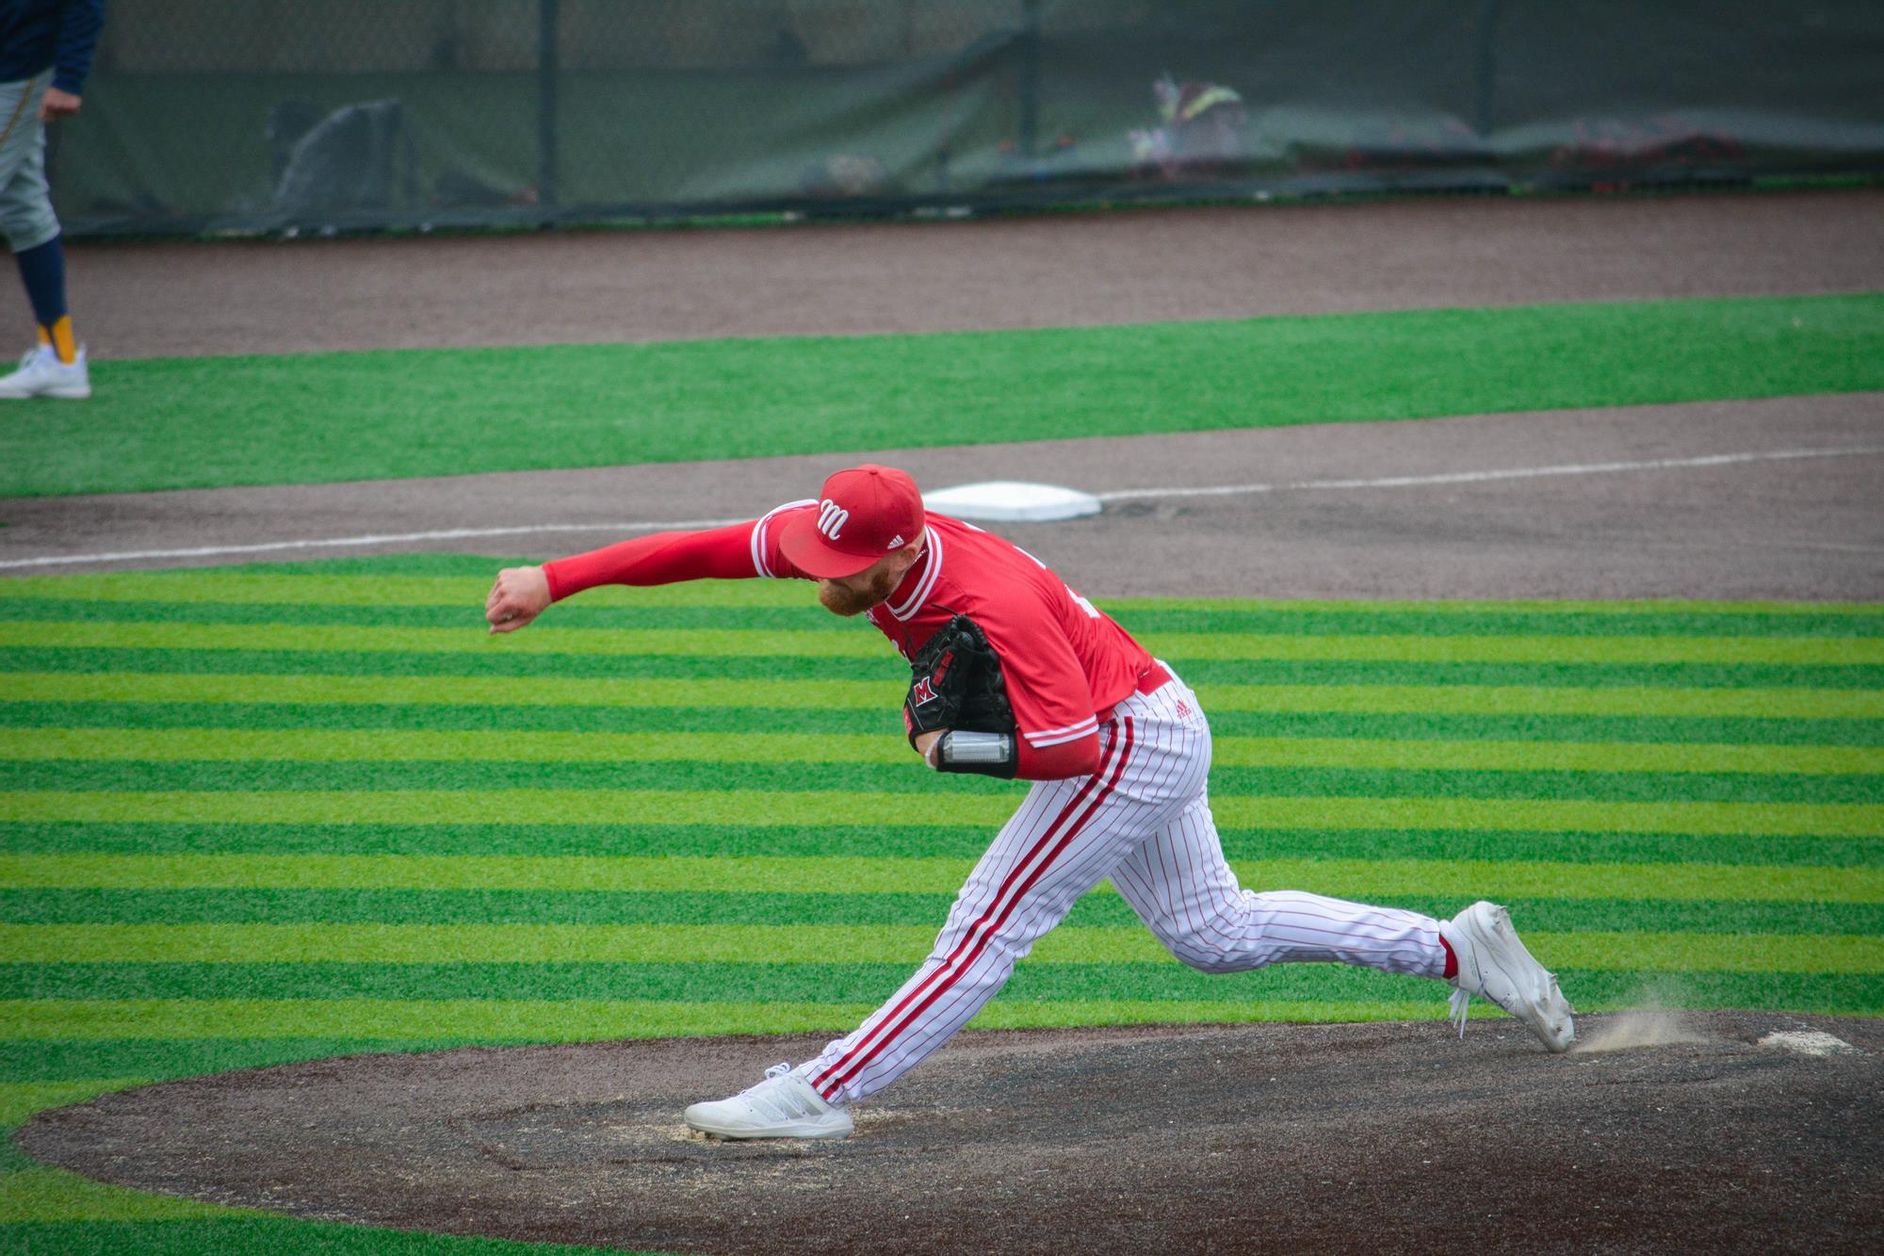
[806,662,1445,1102]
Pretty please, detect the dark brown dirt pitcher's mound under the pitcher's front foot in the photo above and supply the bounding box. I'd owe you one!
[19,1013,1884,1256]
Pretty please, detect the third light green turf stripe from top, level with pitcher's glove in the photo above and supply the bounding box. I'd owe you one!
[11,672,1884,721]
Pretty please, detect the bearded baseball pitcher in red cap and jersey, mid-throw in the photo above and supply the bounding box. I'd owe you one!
[484,465,1573,1139]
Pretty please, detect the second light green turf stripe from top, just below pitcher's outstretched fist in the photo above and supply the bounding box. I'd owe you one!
[0,620,1884,667]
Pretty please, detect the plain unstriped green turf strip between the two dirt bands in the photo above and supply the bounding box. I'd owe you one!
[0,294,1884,497]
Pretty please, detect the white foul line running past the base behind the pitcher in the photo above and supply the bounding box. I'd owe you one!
[0,444,1884,569]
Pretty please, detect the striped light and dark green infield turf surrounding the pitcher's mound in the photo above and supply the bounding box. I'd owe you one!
[0,557,1884,1252]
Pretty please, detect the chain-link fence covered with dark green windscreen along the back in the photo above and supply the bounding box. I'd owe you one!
[51,0,1884,233]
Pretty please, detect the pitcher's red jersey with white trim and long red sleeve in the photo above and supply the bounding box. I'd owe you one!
[544,499,1151,776]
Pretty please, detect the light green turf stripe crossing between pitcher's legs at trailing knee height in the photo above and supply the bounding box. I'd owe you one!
[0,923,1884,974]
